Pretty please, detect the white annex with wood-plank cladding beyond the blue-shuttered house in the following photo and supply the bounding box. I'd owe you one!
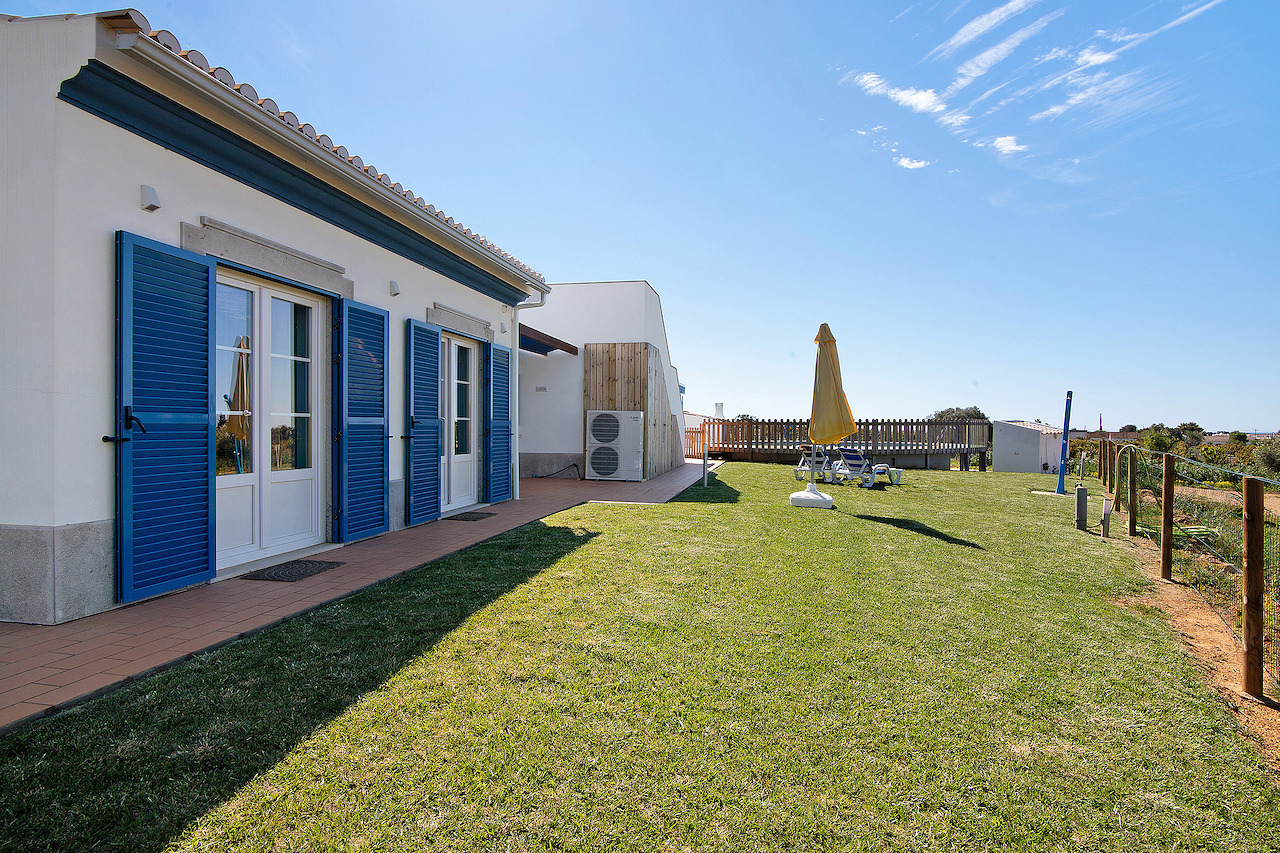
[518,280,685,480]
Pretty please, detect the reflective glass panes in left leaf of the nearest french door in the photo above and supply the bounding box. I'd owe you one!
[214,284,253,474]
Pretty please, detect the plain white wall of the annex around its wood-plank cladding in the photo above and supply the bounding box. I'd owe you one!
[520,282,684,453]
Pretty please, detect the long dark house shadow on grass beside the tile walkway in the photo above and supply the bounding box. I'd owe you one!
[0,521,598,852]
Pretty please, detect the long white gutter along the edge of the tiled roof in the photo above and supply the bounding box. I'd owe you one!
[115,32,545,290]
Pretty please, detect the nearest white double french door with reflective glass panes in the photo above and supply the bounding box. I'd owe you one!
[214,269,328,571]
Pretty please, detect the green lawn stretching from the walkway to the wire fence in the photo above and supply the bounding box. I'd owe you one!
[0,464,1280,850]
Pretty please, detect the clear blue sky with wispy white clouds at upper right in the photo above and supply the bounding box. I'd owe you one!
[12,0,1280,432]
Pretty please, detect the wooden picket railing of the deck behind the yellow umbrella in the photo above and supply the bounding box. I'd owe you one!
[685,419,991,456]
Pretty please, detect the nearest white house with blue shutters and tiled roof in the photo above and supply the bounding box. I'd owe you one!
[0,10,548,624]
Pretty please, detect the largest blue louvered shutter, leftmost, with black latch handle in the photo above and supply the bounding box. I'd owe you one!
[115,231,216,602]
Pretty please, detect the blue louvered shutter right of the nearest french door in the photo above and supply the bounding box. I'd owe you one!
[334,300,390,542]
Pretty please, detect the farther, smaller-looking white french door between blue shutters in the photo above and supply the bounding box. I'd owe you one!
[440,333,483,512]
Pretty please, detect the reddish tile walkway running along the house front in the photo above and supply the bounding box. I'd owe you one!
[0,460,721,733]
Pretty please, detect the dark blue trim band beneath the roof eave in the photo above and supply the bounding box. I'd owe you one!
[58,59,527,305]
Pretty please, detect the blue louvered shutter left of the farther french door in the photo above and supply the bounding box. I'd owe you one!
[404,320,442,524]
